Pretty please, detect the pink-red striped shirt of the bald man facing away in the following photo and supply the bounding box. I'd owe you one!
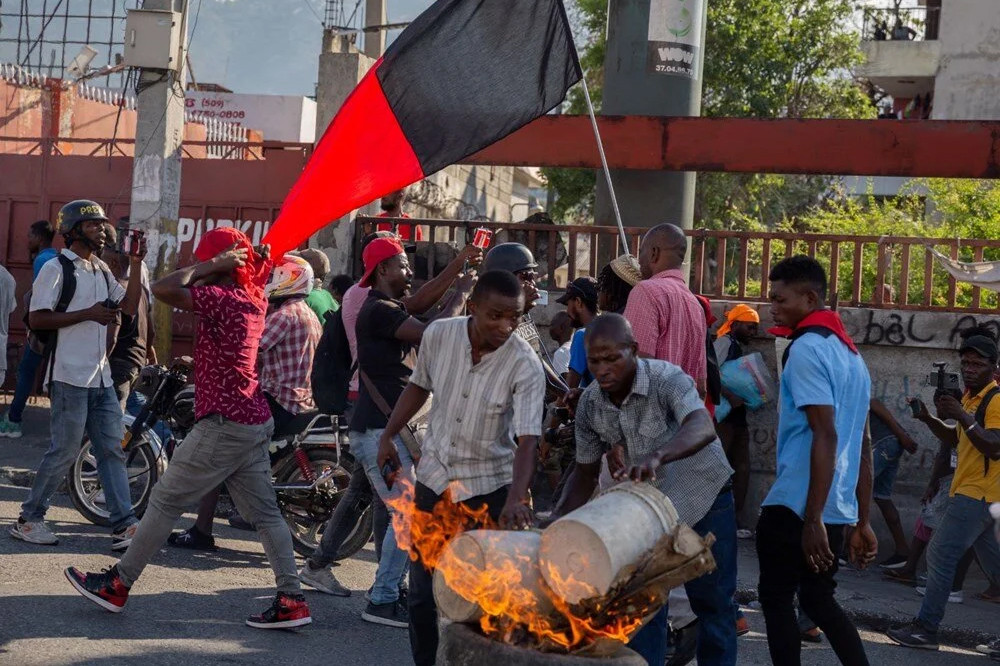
[625,269,707,390]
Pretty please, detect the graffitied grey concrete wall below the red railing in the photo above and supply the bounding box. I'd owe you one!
[532,293,1000,544]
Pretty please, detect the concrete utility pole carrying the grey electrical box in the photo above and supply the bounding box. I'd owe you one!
[129,0,188,359]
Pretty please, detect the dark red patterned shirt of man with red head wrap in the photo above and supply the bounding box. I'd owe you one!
[191,285,271,425]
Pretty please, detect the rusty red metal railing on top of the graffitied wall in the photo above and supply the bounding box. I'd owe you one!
[357,217,1000,313]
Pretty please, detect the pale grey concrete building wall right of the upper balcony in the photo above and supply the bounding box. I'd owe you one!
[932,0,1000,120]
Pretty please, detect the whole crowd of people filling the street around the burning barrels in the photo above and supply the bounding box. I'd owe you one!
[0,195,1000,666]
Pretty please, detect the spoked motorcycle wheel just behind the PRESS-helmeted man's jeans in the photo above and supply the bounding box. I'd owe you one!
[66,438,160,527]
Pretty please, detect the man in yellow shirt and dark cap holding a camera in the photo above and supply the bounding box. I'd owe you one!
[887,330,1000,650]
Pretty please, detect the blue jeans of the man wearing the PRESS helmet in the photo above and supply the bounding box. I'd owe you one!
[21,382,136,532]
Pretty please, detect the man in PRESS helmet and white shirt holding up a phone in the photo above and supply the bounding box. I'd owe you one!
[10,200,145,550]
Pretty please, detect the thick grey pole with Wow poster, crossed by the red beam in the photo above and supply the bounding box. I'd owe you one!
[596,0,709,274]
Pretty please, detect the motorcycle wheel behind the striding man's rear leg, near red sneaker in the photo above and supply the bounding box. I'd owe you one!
[274,447,373,560]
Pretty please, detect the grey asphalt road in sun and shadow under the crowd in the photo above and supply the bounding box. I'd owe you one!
[0,485,991,666]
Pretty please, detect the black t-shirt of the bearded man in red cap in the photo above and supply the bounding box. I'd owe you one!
[351,289,417,432]
